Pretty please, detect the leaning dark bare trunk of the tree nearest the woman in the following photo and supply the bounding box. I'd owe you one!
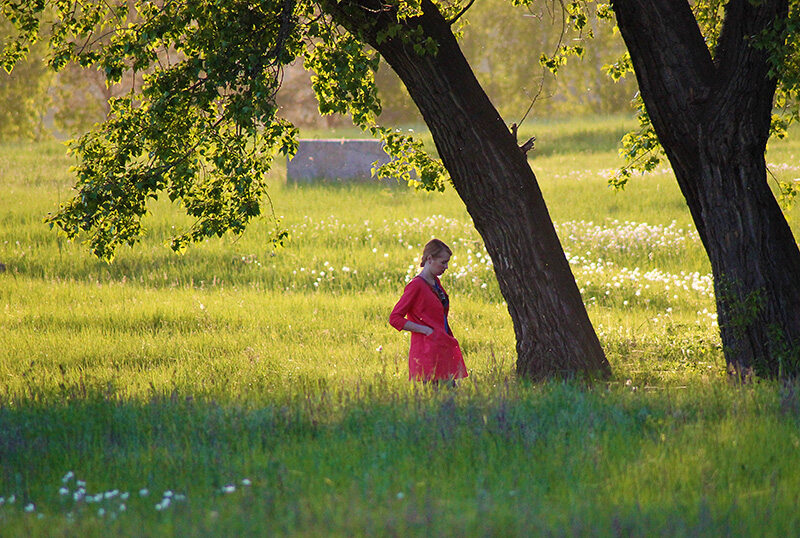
[328,0,609,379]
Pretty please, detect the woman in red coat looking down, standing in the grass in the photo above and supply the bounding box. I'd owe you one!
[389,239,467,383]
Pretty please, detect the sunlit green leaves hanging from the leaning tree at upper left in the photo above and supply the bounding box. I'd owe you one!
[0,0,446,260]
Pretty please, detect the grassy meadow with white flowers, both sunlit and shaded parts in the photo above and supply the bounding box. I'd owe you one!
[0,118,800,536]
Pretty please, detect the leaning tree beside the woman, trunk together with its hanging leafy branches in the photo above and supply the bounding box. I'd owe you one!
[3,0,609,379]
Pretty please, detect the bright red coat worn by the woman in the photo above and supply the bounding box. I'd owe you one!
[389,276,467,381]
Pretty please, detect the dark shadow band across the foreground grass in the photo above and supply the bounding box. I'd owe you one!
[0,378,796,535]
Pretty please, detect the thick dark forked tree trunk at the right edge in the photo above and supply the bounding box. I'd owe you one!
[612,0,800,378]
